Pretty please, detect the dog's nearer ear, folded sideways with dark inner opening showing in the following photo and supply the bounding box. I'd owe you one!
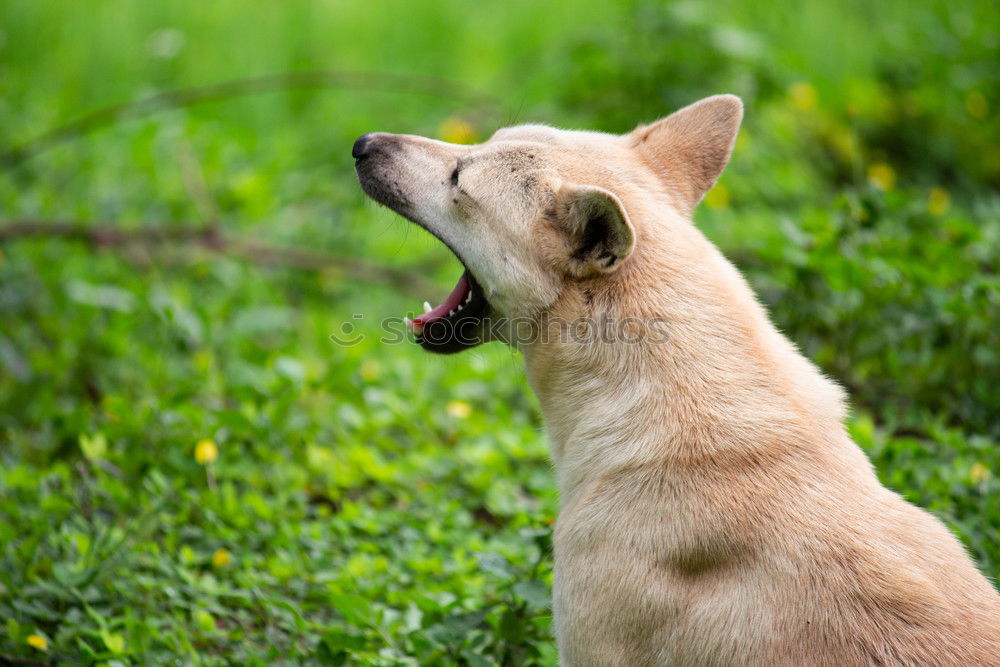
[556,183,635,277]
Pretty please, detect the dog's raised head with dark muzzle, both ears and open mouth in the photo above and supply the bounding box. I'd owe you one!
[353,95,743,352]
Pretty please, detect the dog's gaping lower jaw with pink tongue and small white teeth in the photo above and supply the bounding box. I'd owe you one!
[405,269,489,353]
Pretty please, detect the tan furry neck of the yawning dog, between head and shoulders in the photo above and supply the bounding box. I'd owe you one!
[524,219,853,502]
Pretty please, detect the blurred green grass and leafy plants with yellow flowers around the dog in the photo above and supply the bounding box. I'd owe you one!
[0,0,1000,666]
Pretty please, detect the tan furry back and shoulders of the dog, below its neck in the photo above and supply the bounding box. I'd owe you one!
[555,430,1000,666]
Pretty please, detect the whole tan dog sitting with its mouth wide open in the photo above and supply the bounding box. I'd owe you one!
[354,95,1000,667]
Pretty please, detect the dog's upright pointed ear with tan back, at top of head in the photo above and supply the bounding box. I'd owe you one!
[629,95,743,215]
